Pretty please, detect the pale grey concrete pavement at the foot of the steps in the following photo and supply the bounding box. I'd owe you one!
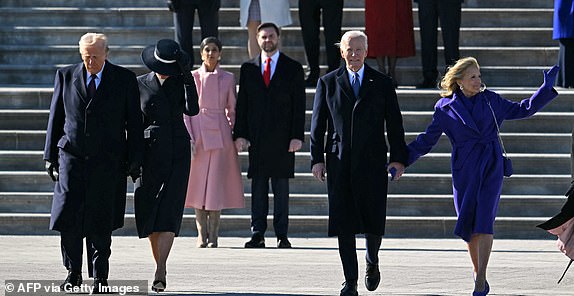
[0,236,574,296]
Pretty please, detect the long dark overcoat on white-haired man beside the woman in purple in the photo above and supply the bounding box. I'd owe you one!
[311,64,407,236]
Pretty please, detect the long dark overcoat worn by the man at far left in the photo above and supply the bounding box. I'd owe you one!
[44,61,143,235]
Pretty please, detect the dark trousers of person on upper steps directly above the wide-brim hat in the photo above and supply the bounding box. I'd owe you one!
[173,0,221,65]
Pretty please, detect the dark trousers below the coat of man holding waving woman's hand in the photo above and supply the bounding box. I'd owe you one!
[338,233,383,282]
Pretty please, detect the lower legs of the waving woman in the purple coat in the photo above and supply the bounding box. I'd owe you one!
[468,233,493,292]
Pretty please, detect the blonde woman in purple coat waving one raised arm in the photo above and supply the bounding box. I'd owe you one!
[408,57,558,296]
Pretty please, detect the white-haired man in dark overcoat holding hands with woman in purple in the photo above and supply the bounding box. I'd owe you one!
[311,31,407,295]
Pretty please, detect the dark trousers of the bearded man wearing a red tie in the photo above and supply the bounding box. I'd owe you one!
[251,177,289,238]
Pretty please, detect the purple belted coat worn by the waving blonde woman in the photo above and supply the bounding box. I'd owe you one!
[408,86,558,242]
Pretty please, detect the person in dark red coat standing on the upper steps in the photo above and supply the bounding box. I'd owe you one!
[365,0,415,87]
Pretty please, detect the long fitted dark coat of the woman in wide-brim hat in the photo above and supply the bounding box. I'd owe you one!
[134,72,199,238]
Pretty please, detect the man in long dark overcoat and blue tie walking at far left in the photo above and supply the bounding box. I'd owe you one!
[44,33,143,291]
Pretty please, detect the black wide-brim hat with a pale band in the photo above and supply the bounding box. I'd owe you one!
[142,39,191,76]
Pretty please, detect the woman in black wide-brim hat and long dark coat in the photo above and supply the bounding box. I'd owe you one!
[134,39,199,292]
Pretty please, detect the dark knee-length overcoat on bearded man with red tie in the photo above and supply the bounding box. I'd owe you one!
[233,53,305,178]
